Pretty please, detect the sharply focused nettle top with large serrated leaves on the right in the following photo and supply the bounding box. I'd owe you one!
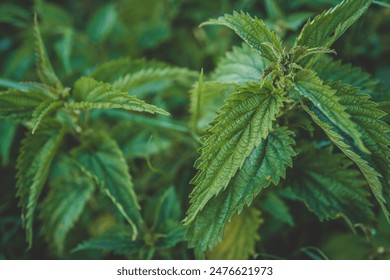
[185,0,390,257]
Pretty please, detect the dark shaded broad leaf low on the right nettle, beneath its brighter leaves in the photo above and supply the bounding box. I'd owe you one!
[289,145,374,225]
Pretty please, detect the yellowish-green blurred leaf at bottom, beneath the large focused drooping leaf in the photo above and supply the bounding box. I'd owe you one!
[207,208,263,260]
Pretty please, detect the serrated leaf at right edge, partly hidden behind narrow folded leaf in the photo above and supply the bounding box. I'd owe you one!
[304,83,390,220]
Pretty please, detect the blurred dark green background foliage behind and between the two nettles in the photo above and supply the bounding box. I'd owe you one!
[0,0,390,259]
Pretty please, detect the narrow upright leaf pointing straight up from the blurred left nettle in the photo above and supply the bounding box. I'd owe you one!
[34,15,62,90]
